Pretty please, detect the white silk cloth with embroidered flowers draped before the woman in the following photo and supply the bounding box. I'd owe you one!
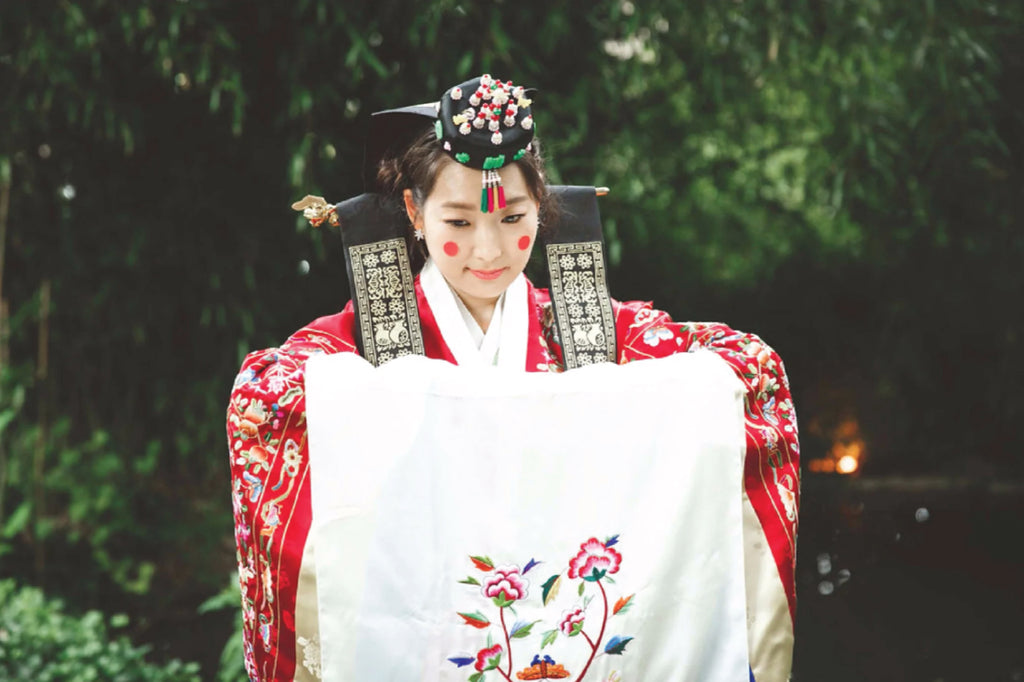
[306,351,749,682]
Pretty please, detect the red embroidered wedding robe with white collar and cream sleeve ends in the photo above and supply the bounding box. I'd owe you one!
[227,266,799,682]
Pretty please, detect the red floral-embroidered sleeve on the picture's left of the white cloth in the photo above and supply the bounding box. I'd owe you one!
[227,316,354,681]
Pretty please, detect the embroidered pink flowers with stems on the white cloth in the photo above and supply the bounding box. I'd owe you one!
[449,536,634,682]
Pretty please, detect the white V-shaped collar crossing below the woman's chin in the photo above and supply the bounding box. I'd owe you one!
[420,258,529,372]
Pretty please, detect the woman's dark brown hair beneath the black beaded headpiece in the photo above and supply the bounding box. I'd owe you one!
[377,127,558,271]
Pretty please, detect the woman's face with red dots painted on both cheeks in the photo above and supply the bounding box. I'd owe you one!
[406,163,539,310]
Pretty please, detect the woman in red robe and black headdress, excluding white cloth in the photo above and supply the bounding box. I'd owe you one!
[227,75,799,682]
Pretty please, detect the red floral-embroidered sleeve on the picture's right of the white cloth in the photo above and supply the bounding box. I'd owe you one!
[615,301,800,616]
